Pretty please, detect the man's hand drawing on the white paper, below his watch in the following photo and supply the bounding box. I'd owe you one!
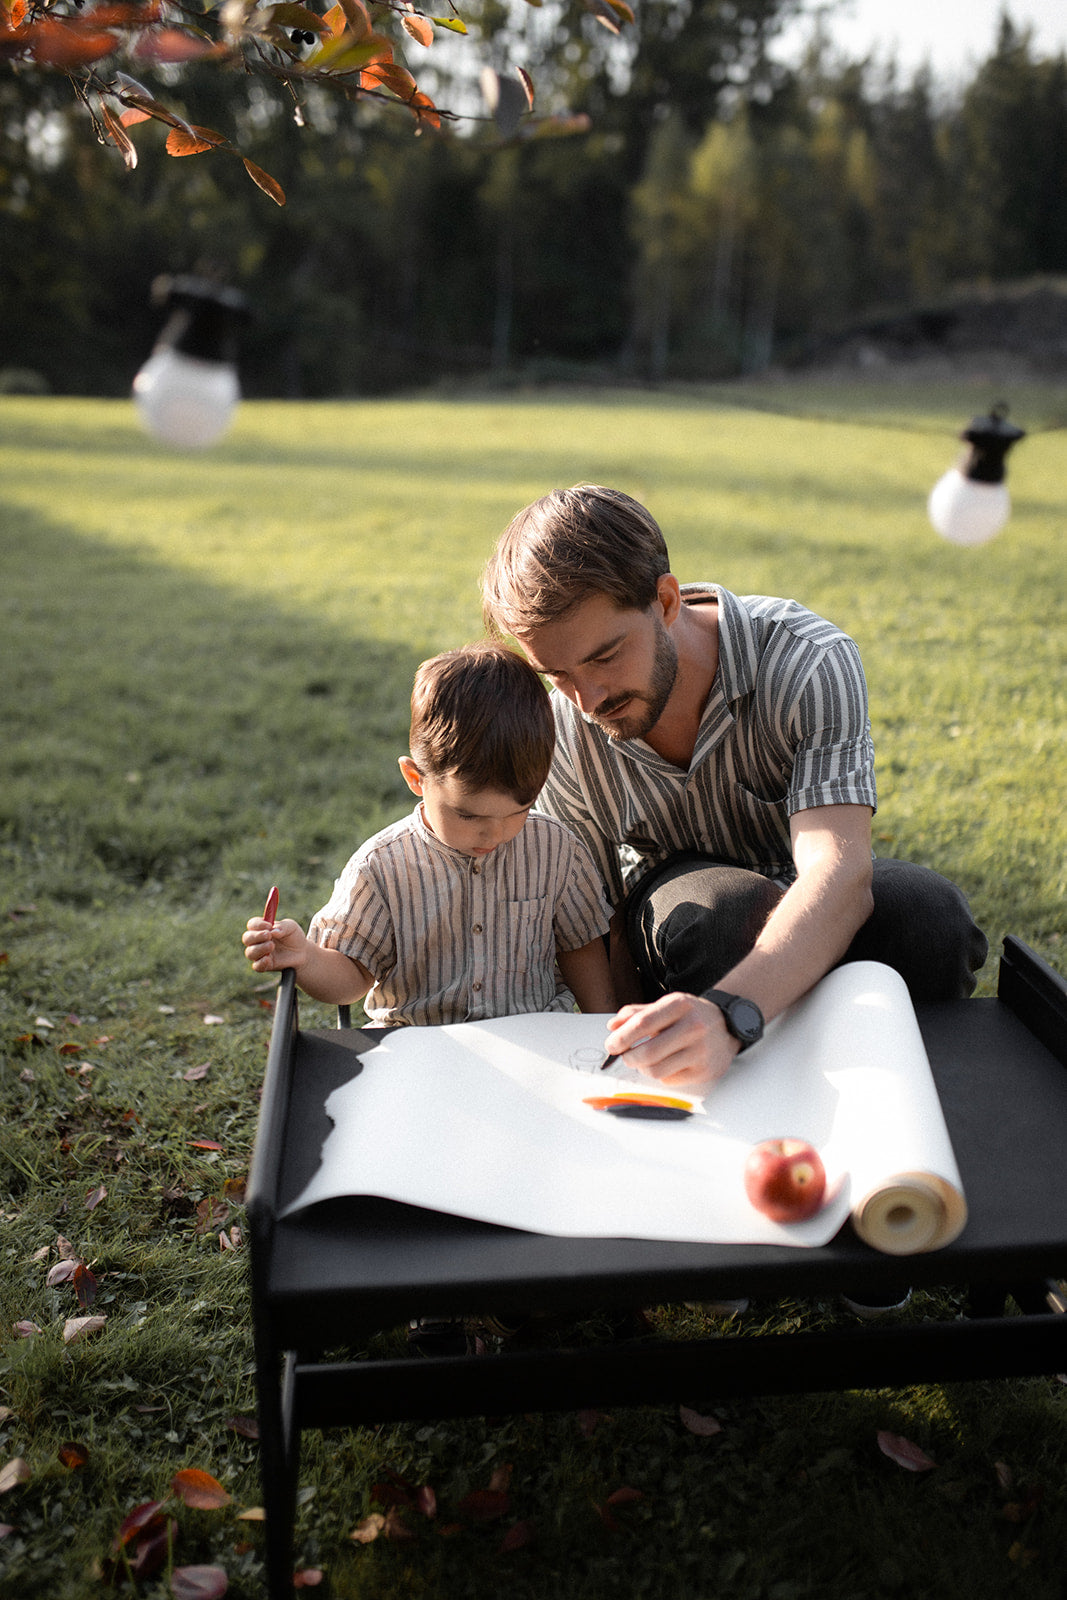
[605,994,741,1091]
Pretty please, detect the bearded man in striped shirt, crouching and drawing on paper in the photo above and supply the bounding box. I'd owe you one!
[483,485,987,1088]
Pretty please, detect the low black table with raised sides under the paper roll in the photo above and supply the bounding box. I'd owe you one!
[246,938,1067,1600]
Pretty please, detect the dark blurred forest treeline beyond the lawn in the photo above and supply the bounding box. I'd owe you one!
[0,0,1067,398]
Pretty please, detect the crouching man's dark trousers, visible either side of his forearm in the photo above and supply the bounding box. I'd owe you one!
[625,854,989,1000]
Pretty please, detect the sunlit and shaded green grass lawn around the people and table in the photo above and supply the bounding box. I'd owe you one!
[0,382,1067,1600]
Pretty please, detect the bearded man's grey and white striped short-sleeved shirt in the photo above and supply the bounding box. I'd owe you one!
[537,584,877,904]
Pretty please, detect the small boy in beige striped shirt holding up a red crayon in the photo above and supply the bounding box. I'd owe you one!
[242,643,616,1026]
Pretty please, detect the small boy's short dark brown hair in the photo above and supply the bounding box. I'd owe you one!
[411,643,555,805]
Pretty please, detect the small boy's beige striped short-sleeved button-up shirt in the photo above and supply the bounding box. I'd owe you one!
[309,805,609,1026]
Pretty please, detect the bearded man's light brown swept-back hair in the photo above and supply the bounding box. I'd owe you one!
[482,483,670,635]
